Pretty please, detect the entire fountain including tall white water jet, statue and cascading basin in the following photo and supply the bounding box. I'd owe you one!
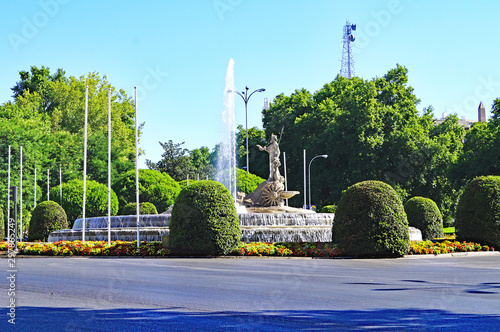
[49,59,334,242]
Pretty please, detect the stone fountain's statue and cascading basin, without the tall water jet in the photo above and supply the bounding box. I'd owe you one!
[48,135,334,242]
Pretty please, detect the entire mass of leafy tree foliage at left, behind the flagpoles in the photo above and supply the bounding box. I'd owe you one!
[0,66,139,231]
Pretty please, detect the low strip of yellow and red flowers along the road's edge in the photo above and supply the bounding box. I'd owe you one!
[0,240,495,257]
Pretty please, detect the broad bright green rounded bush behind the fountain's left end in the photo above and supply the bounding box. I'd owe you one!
[50,179,118,227]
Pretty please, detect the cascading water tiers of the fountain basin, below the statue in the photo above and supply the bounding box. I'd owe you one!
[48,213,333,242]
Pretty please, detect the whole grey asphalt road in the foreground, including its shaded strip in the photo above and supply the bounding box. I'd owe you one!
[0,255,500,331]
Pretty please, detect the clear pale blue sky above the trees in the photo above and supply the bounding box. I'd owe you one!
[0,0,500,167]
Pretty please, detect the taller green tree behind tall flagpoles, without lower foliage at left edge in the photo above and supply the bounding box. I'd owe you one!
[12,67,142,182]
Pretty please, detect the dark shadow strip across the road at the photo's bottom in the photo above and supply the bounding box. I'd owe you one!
[0,306,500,331]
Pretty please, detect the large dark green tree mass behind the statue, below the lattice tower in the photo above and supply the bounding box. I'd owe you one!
[263,65,463,219]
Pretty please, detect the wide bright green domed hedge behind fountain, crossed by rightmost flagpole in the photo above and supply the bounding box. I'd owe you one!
[113,169,181,212]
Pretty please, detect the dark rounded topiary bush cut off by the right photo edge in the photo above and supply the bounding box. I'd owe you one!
[455,175,500,247]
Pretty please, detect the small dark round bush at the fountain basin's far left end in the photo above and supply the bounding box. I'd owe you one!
[28,201,68,242]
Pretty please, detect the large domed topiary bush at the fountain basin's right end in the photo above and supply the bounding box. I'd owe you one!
[334,181,410,257]
